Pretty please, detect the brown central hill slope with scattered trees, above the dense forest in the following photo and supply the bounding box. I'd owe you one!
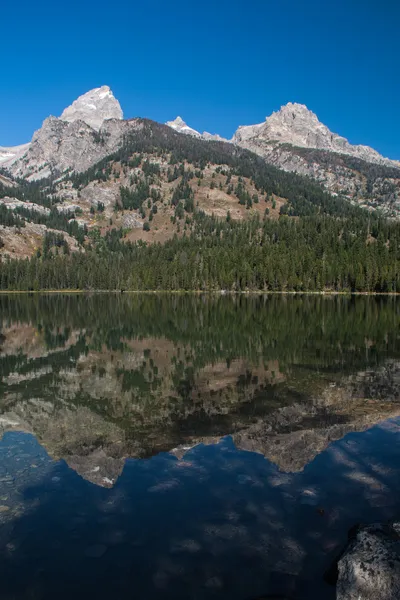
[0,119,368,257]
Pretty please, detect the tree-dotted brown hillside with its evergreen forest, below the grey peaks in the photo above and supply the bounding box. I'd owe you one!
[0,120,400,292]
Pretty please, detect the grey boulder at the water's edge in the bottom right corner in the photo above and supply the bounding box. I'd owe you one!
[336,523,400,600]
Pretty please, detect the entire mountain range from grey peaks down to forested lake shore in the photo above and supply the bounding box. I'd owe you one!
[0,88,400,292]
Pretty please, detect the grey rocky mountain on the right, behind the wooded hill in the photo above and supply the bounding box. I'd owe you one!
[232,102,400,217]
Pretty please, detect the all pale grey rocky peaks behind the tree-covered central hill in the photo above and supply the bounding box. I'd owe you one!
[0,86,400,217]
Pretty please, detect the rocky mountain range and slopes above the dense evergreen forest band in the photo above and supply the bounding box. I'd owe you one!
[0,86,400,258]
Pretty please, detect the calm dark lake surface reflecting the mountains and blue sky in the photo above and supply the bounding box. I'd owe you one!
[0,295,400,600]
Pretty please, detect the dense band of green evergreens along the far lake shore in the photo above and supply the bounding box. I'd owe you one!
[0,212,400,293]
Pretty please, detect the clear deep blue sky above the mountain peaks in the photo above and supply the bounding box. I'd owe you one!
[0,0,400,159]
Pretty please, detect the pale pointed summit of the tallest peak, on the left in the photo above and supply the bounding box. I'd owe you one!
[60,85,123,130]
